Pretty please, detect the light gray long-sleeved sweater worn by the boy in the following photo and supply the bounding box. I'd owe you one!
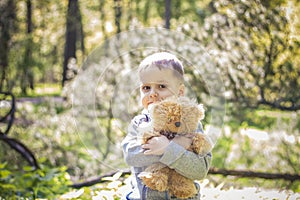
[122,113,211,200]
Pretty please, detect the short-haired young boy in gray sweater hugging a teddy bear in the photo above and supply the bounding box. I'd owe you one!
[122,52,211,200]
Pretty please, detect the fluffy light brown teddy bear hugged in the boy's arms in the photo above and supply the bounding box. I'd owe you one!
[139,97,212,199]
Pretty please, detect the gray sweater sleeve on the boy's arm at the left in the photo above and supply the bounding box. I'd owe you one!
[122,117,160,167]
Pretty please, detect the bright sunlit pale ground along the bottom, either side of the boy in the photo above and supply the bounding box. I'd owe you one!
[60,179,300,200]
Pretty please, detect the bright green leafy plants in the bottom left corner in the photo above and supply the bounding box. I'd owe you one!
[0,159,71,199]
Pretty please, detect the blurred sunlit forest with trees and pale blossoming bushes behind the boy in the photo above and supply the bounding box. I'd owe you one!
[0,0,300,199]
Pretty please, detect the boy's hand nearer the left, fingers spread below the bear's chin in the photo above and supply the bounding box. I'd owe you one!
[142,135,170,155]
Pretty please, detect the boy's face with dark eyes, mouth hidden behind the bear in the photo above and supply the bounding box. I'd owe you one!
[139,67,184,109]
